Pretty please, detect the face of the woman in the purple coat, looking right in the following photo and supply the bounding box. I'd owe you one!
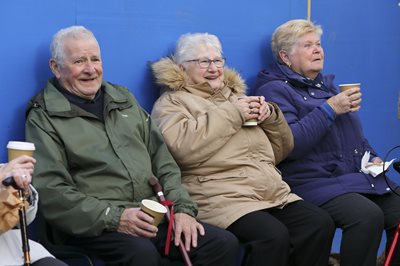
[288,33,324,79]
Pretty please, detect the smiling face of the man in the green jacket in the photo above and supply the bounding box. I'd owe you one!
[50,38,103,100]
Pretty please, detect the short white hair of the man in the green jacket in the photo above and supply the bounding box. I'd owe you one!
[50,26,100,66]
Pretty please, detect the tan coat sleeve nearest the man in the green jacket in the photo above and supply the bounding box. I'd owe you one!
[152,95,243,167]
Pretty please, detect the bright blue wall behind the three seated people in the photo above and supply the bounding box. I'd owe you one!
[0,0,400,254]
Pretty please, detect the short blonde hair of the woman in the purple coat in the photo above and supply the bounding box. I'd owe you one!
[271,19,322,63]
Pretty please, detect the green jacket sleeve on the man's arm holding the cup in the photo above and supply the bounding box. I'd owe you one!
[25,108,123,236]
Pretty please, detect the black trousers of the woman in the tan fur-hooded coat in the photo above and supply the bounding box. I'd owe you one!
[227,201,335,266]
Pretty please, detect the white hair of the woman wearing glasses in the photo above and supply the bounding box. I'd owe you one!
[174,32,222,65]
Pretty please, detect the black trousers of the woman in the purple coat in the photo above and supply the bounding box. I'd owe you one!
[321,189,400,266]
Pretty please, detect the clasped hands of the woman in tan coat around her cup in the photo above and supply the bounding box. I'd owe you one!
[236,96,271,123]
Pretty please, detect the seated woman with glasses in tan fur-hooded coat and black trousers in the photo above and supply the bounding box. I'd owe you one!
[152,33,334,266]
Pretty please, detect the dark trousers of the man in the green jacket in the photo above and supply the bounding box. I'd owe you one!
[69,223,239,266]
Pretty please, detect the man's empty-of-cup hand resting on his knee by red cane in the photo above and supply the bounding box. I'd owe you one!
[174,213,205,252]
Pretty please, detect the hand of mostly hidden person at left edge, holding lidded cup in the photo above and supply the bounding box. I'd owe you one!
[0,155,36,189]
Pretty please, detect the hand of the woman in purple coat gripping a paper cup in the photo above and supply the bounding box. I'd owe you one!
[327,88,361,115]
